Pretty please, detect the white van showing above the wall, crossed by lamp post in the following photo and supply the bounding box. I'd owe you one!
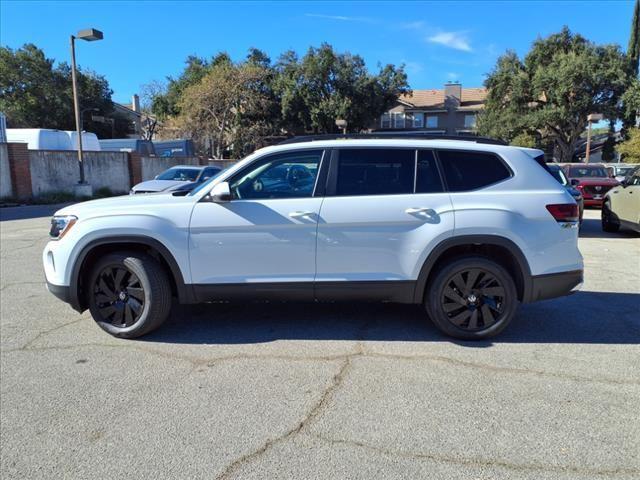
[6,128,101,152]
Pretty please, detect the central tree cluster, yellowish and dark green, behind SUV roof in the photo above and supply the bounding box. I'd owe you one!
[151,44,408,157]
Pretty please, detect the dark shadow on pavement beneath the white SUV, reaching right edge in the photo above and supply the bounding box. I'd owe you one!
[141,292,640,348]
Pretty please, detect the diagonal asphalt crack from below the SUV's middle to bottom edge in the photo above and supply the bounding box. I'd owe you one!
[216,350,362,480]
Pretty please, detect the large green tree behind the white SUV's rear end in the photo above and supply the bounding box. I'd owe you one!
[478,27,632,162]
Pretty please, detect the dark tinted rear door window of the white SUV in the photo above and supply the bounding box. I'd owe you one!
[336,148,415,195]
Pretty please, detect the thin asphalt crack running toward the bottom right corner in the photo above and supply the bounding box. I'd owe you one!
[306,433,640,476]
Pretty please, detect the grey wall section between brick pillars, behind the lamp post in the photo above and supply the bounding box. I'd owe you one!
[29,150,129,197]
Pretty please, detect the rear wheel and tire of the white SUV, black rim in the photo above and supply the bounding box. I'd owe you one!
[425,255,518,340]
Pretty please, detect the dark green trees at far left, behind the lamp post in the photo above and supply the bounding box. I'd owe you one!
[0,44,113,130]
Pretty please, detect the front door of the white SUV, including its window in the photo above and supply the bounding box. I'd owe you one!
[190,150,326,284]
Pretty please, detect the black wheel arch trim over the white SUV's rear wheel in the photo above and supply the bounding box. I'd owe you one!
[413,235,532,304]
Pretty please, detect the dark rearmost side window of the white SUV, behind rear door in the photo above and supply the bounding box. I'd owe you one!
[438,150,511,192]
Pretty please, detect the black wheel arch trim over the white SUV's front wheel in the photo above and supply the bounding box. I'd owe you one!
[69,235,194,312]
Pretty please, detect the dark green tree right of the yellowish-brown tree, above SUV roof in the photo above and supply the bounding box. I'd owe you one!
[275,44,409,133]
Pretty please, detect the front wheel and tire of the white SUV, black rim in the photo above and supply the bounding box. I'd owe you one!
[87,252,172,338]
